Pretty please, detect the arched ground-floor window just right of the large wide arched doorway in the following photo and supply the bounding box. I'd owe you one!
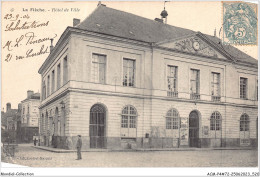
[121,106,137,128]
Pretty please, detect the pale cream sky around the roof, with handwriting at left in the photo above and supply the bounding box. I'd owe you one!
[1,1,258,110]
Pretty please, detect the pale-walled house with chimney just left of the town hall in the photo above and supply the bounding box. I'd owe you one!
[21,90,40,143]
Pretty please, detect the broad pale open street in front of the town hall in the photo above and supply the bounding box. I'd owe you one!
[2,145,258,167]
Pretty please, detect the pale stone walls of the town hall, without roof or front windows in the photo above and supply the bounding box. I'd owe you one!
[39,4,258,149]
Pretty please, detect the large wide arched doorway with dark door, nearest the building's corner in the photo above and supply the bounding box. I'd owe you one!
[89,104,106,148]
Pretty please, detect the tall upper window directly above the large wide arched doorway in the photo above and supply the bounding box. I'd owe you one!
[92,54,106,84]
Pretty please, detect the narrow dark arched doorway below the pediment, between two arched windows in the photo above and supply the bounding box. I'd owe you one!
[189,111,199,147]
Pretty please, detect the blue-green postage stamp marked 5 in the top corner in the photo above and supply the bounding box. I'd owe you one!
[223,2,257,45]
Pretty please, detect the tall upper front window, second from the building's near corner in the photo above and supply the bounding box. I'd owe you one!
[123,58,135,87]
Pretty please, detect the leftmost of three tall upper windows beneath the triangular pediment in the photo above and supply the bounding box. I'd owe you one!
[167,66,178,92]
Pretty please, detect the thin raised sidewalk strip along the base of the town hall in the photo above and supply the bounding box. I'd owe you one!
[31,146,257,153]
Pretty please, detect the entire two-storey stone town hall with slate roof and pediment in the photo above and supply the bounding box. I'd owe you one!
[37,4,258,149]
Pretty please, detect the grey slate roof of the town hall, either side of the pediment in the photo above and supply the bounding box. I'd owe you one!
[76,5,258,64]
